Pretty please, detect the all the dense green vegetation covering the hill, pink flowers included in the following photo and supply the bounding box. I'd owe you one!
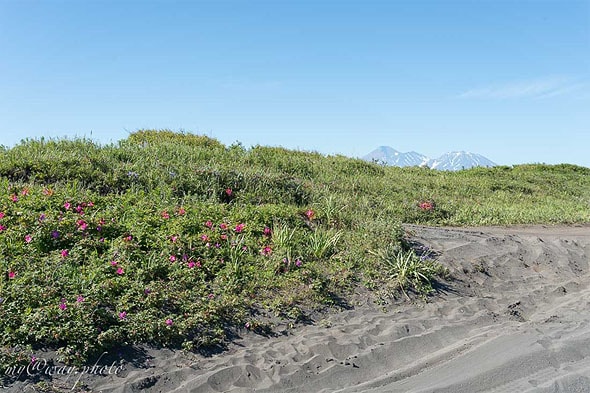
[0,131,590,370]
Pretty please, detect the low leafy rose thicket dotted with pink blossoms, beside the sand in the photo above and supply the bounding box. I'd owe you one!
[0,183,336,363]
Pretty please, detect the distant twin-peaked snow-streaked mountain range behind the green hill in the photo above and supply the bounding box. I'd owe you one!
[363,146,496,171]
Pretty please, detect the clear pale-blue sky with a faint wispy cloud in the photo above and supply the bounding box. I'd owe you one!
[0,0,590,167]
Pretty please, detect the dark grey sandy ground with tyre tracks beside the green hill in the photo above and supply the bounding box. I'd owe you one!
[7,226,590,393]
